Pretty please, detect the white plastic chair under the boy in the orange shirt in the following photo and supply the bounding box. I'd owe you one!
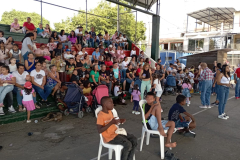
[95,106,135,160]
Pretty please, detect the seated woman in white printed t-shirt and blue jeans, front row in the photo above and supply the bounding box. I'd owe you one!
[30,62,52,106]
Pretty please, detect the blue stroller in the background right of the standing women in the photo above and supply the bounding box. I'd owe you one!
[163,74,176,96]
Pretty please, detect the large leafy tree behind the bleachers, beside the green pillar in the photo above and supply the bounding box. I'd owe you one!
[54,1,146,42]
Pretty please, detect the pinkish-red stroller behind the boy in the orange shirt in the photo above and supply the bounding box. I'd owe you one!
[92,85,109,111]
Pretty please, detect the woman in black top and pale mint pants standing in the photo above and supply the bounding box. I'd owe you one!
[139,63,152,99]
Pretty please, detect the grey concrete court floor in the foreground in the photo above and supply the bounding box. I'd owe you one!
[0,90,240,160]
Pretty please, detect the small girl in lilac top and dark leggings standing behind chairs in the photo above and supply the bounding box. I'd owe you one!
[131,84,141,115]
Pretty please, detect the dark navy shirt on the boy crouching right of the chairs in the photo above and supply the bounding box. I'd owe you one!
[168,103,186,122]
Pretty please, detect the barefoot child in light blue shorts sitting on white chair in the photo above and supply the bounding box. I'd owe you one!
[142,92,177,148]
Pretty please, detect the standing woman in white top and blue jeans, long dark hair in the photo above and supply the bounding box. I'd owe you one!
[217,65,231,120]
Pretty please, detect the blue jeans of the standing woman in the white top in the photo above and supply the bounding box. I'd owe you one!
[218,86,229,115]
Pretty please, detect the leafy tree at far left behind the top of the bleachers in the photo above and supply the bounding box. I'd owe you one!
[0,9,50,28]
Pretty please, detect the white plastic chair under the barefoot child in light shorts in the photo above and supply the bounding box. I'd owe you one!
[139,100,172,159]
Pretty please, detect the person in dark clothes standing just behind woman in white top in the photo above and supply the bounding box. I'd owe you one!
[212,63,222,106]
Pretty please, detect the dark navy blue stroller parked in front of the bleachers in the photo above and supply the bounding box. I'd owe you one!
[64,83,91,118]
